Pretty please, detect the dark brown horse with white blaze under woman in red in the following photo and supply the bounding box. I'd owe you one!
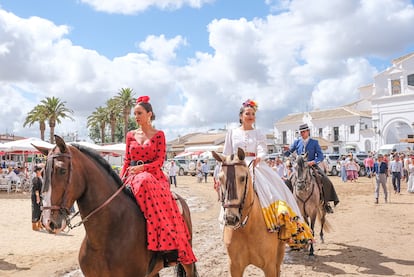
[37,136,197,277]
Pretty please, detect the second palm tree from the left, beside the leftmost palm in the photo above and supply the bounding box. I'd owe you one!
[40,96,73,143]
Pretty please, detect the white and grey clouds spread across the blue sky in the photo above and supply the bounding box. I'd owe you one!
[0,0,414,142]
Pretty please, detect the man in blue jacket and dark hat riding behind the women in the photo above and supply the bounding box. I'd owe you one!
[285,123,339,213]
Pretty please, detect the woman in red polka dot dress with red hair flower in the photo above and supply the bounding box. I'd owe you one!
[120,96,197,264]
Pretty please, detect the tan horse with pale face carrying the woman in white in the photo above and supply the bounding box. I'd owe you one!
[212,148,285,277]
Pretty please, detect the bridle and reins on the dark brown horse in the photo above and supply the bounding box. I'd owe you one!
[42,149,126,230]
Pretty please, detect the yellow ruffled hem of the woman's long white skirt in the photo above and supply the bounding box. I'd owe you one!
[262,200,313,248]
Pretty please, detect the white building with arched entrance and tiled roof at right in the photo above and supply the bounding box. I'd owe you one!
[274,53,414,153]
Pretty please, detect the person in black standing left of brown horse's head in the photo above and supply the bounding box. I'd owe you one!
[31,166,43,231]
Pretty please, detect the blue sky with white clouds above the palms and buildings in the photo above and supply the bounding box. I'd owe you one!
[0,0,414,141]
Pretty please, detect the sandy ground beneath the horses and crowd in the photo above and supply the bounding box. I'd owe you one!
[0,176,414,277]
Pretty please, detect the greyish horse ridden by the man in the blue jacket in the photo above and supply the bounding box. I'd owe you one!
[290,155,328,256]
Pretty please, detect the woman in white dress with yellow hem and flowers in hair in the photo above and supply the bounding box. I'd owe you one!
[223,99,313,247]
